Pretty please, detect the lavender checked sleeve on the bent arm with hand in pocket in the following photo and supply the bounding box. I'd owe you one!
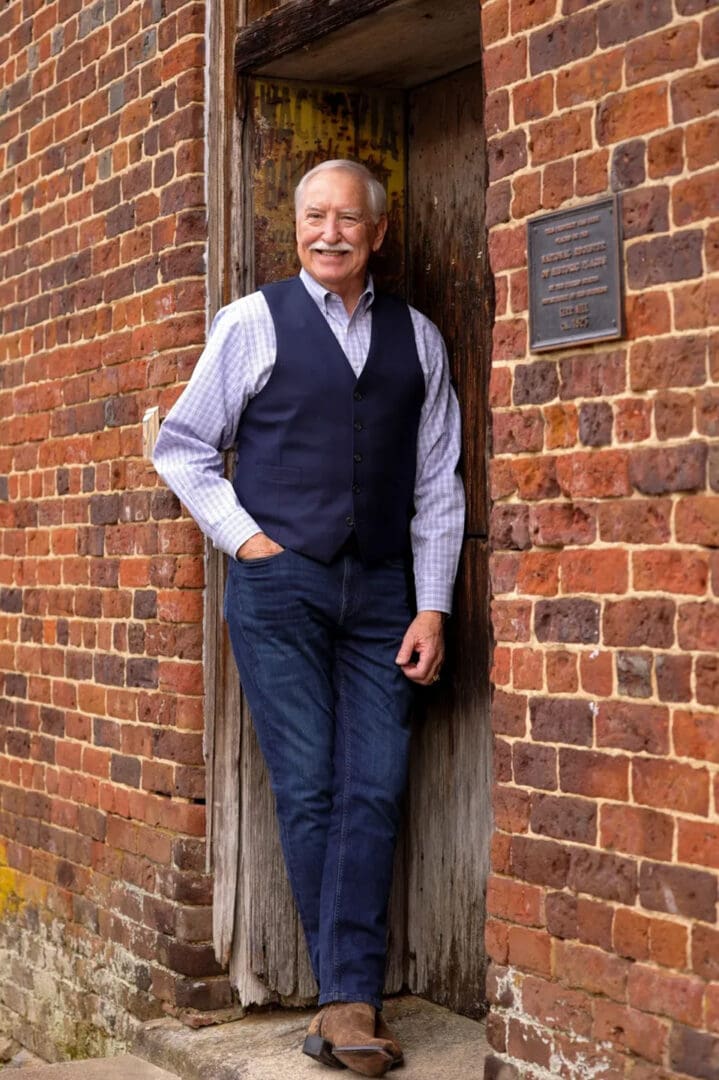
[152,293,276,557]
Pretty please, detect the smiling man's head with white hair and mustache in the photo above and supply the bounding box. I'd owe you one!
[297,168,386,312]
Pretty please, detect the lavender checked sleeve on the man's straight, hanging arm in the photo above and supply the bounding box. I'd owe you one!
[410,309,464,613]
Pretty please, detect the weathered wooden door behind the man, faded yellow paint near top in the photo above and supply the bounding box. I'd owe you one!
[208,0,490,1015]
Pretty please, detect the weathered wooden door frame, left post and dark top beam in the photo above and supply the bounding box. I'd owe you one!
[203,0,491,1010]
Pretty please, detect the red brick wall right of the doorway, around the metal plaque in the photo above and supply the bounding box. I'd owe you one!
[481,0,719,1080]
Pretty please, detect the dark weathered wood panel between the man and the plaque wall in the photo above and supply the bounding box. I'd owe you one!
[407,66,491,1016]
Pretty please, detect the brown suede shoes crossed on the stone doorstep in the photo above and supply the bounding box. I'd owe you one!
[302,1001,402,1077]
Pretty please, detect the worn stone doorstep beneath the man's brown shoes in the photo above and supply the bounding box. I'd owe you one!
[132,997,489,1080]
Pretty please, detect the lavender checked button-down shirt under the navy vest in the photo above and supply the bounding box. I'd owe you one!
[152,270,464,612]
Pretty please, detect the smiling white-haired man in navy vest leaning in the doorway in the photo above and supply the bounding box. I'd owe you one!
[154,161,464,1077]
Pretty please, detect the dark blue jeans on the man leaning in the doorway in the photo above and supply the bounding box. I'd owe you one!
[225,550,413,1008]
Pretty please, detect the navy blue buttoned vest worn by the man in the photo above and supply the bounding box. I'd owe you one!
[234,278,424,564]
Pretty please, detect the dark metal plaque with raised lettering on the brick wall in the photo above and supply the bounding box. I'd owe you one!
[527,195,623,352]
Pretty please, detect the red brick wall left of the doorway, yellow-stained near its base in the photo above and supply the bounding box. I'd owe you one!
[0,0,229,1056]
